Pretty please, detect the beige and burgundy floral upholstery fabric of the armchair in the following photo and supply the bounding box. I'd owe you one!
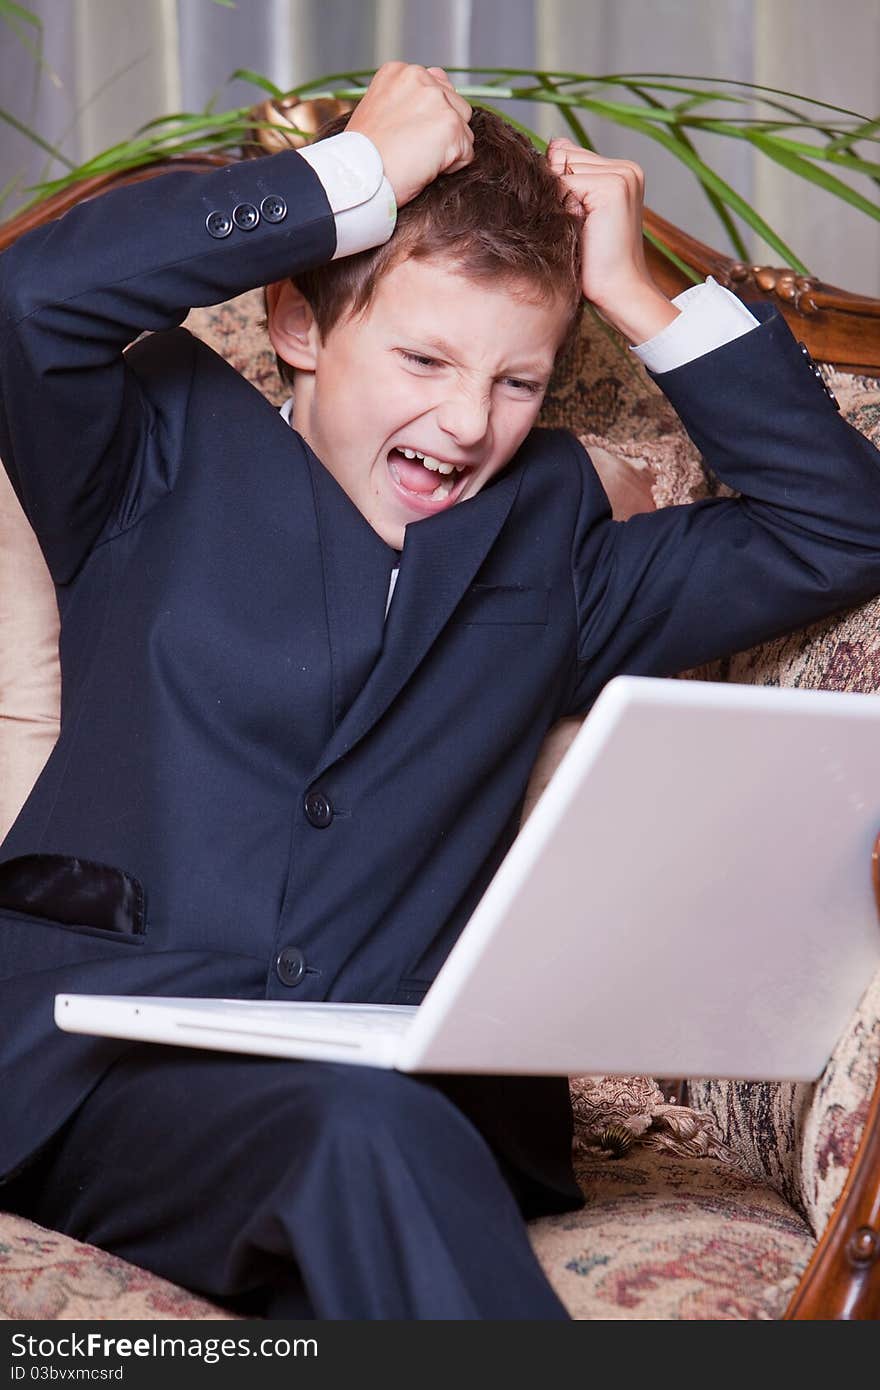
[0,292,880,1321]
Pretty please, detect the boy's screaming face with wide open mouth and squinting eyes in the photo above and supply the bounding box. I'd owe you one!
[284,259,569,550]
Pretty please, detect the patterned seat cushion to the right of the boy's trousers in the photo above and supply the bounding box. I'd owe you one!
[530,1145,813,1321]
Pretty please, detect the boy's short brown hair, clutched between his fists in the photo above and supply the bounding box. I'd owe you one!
[271,108,582,384]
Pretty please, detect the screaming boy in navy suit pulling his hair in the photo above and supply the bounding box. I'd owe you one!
[0,64,880,1319]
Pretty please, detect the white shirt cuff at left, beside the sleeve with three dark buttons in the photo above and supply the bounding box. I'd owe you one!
[299,131,398,260]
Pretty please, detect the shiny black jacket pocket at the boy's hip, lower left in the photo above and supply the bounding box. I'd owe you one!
[0,855,146,941]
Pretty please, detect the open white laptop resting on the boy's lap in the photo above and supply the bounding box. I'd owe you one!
[56,676,880,1080]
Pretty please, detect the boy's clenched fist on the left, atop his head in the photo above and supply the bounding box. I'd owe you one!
[346,63,474,207]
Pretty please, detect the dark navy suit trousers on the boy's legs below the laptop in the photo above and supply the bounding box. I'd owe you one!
[10,1044,582,1319]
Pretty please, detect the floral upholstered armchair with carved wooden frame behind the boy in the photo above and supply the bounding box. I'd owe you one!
[0,132,880,1321]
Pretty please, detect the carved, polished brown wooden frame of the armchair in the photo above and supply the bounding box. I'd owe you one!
[0,153,880,1321]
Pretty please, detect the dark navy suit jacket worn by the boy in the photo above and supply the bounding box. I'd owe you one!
[0,152,880,1173]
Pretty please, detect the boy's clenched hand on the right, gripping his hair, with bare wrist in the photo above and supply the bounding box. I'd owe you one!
[546,138,678,343]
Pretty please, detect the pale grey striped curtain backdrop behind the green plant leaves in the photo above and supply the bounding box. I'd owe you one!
[0,0,880,296]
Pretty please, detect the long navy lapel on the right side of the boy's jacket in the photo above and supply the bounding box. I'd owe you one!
[316,464,520,777]
